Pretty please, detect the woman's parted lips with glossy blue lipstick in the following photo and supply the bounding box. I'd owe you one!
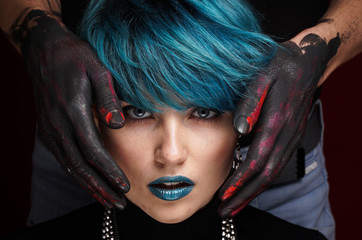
[148,176,194,201]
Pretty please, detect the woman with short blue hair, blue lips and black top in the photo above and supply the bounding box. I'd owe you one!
[6,0,324,239]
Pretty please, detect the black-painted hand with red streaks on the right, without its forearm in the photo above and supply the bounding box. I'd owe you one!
[219,34,340,217]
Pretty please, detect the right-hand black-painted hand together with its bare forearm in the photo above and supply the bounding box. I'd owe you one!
[219,0,362,217]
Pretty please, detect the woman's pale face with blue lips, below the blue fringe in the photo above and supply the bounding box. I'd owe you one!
[99,102,237,223]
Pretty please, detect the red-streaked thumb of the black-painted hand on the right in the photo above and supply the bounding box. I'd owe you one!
[234,74,270,134]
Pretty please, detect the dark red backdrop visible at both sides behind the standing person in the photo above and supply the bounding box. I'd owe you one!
[0,29,362,240]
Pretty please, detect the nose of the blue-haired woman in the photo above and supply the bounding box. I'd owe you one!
[155,118,187,168]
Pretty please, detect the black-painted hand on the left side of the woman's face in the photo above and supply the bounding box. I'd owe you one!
[11,10,129,208]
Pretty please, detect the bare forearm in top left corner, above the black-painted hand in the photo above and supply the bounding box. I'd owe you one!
[0,0,61,52]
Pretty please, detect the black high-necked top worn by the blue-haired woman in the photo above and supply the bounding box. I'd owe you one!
[7,197,326,240]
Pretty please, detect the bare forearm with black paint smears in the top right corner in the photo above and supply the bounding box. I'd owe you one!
[291,0,362,85]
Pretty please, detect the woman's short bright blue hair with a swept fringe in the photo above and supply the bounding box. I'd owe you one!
[80,0,277,111]
